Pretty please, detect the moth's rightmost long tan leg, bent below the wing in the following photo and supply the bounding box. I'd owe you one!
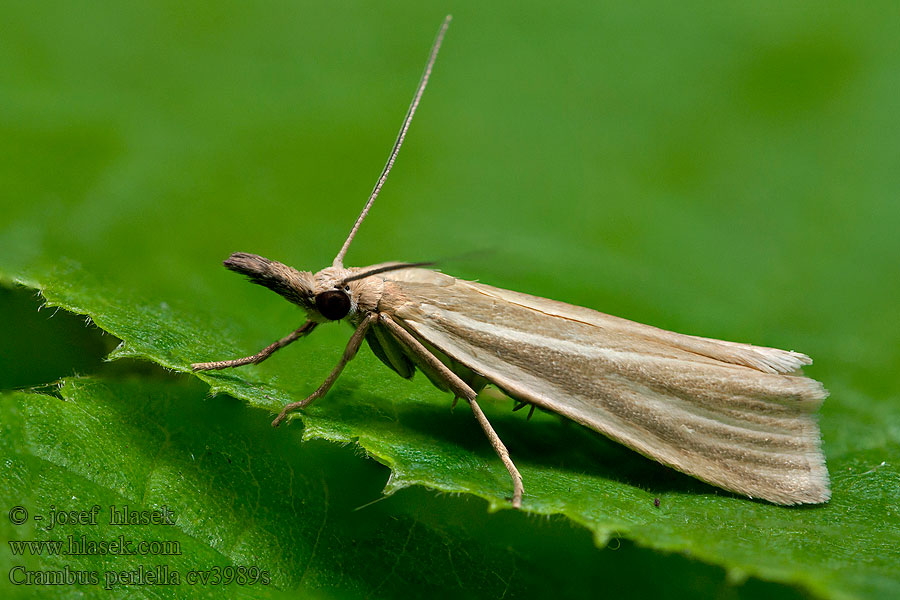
[378,313,525,508]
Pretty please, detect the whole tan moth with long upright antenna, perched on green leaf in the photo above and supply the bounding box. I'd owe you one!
[192,16,830,508]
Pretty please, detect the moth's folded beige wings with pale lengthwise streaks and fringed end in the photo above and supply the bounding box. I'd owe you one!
[385,269,830,504]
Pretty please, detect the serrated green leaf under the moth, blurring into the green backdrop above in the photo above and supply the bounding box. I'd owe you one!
[0,3,900,598]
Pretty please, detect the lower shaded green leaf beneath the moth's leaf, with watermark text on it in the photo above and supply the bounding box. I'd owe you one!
[0,378,804,598]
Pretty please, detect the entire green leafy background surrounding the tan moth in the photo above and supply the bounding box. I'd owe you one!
[0,2,900,598]
